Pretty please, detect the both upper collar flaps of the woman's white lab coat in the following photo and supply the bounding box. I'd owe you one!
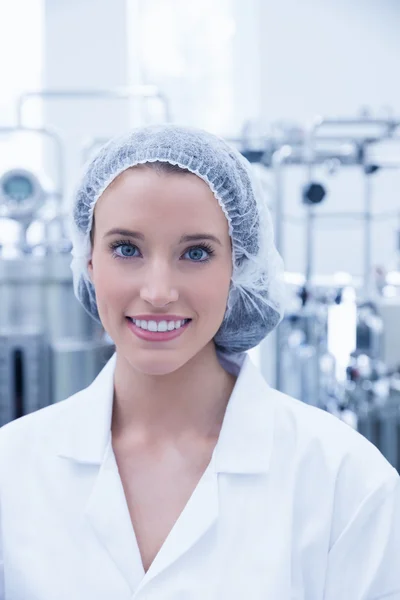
[57,354,274,473]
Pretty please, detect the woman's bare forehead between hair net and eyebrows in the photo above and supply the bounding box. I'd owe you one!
[95,167,228,231]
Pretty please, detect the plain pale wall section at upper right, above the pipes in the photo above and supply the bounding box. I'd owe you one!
[259,0,400,120]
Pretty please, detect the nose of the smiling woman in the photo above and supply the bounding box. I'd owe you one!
[140,262,179,308]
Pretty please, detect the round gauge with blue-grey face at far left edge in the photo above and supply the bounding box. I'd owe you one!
[0,169,46,222]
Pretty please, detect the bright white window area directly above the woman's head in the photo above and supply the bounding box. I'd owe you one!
[127,0,236,135]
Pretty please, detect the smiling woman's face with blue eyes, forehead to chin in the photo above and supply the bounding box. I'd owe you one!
[89,166,232,375]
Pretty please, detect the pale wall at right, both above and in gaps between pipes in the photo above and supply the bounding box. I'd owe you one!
[258,0,400,274]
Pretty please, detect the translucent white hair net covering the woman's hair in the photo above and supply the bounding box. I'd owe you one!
[71,125,284,353]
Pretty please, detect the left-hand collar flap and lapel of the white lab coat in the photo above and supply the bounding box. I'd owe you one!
[55,354,144,592]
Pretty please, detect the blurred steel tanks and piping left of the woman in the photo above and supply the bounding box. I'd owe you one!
[0,127,113,426]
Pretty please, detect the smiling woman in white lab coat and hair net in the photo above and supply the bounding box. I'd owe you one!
[0,126,400,600]
